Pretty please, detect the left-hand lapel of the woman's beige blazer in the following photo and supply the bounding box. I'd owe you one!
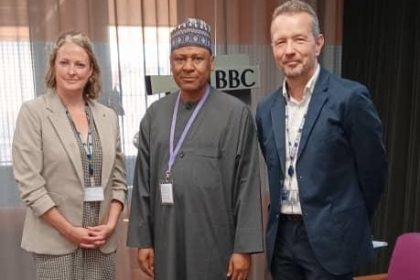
[45,92,84,186]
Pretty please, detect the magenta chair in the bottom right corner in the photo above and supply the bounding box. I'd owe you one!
[354,232,420,280]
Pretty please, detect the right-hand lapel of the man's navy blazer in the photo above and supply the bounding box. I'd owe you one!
[297,68,328,160]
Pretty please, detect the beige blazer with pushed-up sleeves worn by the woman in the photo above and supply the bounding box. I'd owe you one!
[12,92,127,255]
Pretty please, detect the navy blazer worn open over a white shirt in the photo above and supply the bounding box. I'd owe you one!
[256,68,386,274]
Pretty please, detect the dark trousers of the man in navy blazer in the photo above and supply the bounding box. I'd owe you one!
[271,215,353,280]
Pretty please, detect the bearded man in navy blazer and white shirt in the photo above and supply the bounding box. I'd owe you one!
[256,1,386,280]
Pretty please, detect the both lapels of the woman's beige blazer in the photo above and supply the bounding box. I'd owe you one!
[44,92,118,188]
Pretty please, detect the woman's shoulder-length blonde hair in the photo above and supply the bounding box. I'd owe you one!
[45,31,101,100]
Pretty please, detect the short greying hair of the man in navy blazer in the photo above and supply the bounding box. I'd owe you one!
[272,0,321,37]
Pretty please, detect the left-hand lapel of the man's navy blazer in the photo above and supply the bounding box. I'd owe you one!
[271,89,286,173]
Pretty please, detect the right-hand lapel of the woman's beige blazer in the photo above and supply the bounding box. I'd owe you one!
[89,102,115,186]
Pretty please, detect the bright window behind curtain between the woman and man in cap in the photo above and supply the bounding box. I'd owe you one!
[109,26,170,156]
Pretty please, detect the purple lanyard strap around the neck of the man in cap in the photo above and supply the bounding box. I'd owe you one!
[166,86,210,176]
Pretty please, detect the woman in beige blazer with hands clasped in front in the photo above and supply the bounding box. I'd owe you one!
[13,32,127,280]
